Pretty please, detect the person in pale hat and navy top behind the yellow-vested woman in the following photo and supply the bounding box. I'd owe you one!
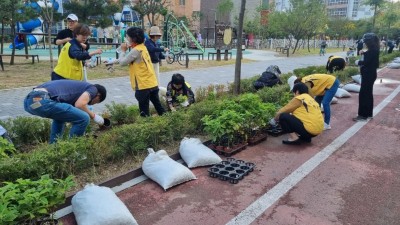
[144,26,169,83]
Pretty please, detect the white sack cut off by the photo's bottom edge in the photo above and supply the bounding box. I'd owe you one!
[71,184,138,225]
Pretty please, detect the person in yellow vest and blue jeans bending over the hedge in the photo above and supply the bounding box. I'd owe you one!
[289,74,340,130]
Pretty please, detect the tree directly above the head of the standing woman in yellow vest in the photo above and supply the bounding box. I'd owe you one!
[132,0,168,29]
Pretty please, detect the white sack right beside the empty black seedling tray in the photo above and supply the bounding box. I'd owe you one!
[179,138,222,168]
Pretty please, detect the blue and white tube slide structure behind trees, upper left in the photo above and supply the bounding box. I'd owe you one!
[10,0,59,49]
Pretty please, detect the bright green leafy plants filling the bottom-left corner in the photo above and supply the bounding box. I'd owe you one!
[0,175,75,224]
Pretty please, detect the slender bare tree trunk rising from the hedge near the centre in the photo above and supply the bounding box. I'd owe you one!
[233,0,246,95]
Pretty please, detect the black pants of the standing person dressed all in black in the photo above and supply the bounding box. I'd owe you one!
[358,69,377,117]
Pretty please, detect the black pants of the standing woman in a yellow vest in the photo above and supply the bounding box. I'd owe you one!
[135,87,165,117]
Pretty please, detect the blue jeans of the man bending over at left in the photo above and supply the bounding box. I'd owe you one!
[24,91,90,143]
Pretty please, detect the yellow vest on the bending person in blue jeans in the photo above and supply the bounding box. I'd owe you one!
[301,74,336,96]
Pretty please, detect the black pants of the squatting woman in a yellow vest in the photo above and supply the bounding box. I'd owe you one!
[279,113,314,141]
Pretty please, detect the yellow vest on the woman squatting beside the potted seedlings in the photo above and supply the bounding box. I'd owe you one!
[293,94,324,135]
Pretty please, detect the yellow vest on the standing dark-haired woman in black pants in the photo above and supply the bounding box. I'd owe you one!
[129,44,158,90]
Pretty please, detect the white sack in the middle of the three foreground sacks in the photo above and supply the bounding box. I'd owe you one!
[142,148,196,190]
